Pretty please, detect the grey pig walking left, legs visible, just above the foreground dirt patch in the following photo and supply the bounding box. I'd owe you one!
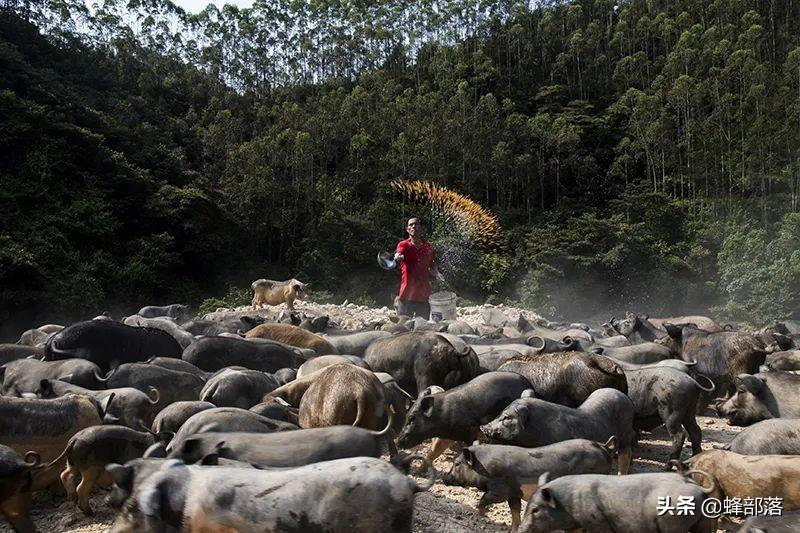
[442,437,616,530]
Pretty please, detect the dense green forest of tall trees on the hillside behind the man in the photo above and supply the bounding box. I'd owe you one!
[0,0,800,333]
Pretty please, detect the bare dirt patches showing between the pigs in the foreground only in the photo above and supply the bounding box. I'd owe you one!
[0,416,742,533]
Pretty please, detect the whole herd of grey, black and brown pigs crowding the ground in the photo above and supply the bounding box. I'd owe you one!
[0,300,800,532]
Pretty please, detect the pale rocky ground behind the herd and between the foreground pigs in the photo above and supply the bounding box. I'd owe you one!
[0,301,752,533]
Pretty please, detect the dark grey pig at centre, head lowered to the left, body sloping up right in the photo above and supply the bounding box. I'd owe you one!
[397,372,530,461]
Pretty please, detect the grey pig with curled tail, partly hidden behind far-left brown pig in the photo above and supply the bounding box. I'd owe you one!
[36,379,159,429]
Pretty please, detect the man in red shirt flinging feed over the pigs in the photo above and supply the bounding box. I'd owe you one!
[394,217,441,320]
